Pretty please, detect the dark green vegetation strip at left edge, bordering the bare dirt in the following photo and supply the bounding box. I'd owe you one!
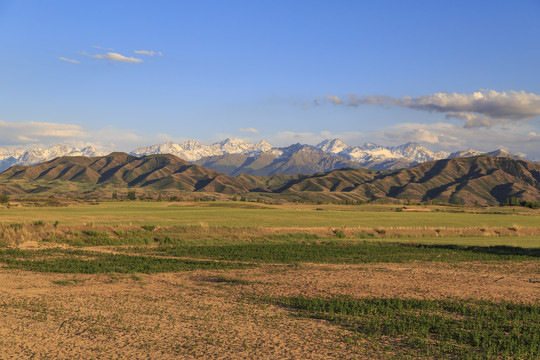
[0,249,253,274]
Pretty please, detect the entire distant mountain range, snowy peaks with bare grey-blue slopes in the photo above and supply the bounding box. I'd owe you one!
[0,138,524,176]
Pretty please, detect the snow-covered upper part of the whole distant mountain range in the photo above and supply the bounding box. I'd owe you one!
[0,138,526,171]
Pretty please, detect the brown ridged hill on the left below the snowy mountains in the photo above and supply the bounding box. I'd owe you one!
[0,153,253,194]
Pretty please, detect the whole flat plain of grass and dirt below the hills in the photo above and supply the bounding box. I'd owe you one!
[0,201,540,359]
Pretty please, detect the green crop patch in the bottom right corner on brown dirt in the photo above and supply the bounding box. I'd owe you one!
[273,297,540,359]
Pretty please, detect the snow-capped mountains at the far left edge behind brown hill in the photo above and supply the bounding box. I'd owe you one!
[0,145,104,171]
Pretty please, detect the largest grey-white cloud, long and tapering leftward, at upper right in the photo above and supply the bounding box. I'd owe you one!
[314,90,540,128]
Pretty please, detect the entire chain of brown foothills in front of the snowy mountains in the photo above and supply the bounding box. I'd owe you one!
[0,152,540,205]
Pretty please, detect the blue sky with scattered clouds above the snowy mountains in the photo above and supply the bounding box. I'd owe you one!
[0,0,540,158]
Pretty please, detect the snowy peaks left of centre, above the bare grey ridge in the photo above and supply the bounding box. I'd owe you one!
[131,138,273,161]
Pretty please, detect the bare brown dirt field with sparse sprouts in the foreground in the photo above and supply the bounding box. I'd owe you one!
[0,262,540,359]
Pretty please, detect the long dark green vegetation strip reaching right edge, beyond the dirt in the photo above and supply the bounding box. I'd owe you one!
[129,241,540,264]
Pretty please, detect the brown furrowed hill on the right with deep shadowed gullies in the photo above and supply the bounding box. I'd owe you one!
[272,156,540,205]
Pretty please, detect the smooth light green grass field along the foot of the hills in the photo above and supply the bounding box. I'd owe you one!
[0,202,540,228]
